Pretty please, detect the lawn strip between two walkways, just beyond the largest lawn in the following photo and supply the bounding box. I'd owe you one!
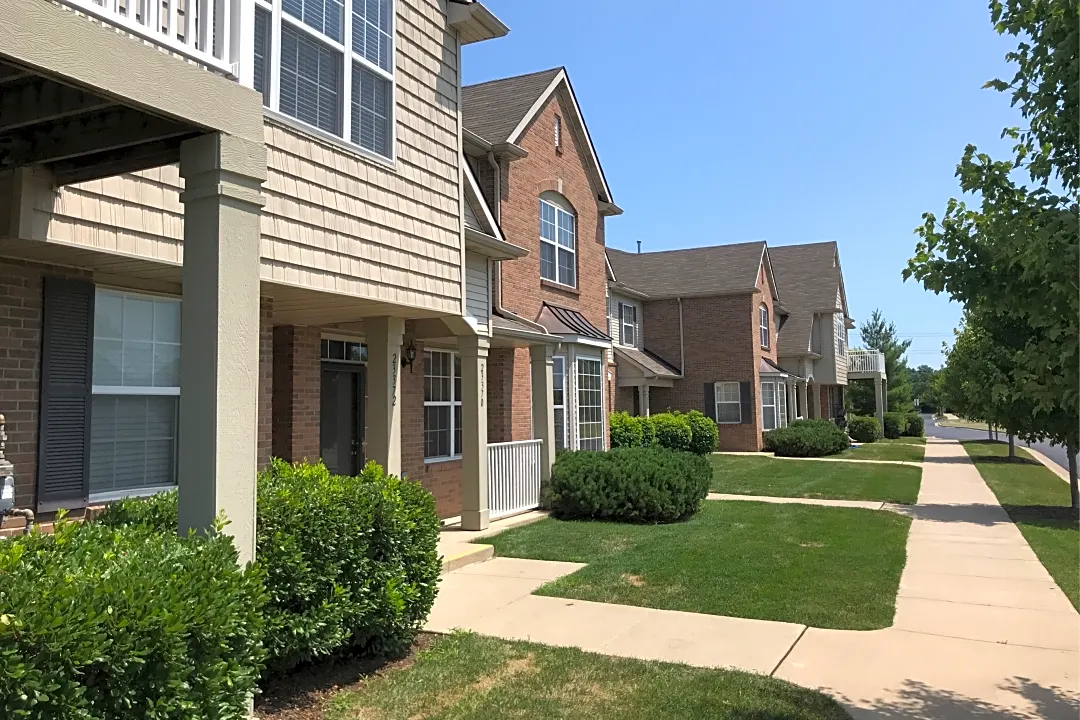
[710,454,922,504]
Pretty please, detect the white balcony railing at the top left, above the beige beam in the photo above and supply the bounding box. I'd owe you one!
[58,0,238,76]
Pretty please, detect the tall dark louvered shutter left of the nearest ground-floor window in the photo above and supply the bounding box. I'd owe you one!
[38,277,94,512]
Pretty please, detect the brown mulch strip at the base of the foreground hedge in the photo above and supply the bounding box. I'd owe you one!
[255,633,438,720]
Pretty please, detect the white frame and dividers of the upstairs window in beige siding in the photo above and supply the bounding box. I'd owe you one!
[246,0,397,167]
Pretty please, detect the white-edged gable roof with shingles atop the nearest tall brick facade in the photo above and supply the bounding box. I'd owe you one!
[461,67,622,215]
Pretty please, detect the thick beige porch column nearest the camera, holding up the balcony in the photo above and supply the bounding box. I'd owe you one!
[177,134,267,563]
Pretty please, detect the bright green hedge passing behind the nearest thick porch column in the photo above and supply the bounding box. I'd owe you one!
[97,460,442,673]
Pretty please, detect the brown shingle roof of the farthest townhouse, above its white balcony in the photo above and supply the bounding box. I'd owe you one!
[769,242,840,355]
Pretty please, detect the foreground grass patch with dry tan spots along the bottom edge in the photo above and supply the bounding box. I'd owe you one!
[326,633,850,720]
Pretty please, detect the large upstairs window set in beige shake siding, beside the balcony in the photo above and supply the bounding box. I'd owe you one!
[253,0,394,159]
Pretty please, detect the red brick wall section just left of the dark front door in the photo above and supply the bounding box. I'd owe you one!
[271,325,322,462]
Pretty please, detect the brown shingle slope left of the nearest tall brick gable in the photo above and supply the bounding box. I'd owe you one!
[461,68,563,145]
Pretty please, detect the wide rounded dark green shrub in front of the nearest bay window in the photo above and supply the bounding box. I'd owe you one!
[551,448,713,522]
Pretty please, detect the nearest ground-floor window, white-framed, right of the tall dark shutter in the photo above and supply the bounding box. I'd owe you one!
[90,289,180,500]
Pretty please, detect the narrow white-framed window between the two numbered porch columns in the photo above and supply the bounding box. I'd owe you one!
[423,350,461,460]
